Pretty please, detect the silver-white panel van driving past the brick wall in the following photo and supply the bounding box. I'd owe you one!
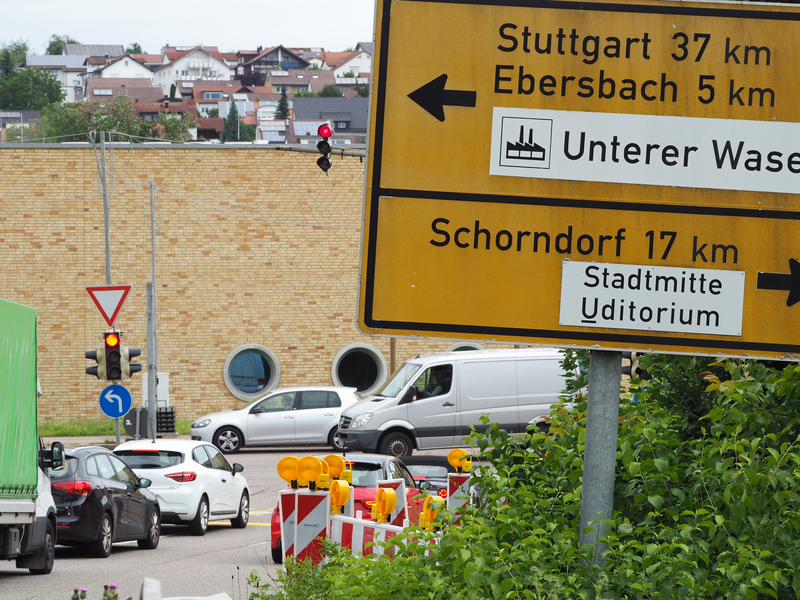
[339,348,566,456]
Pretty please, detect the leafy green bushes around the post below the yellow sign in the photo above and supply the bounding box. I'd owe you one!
[251,353,800,600]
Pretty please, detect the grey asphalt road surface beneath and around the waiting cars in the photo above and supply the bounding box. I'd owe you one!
[0,447,456,600]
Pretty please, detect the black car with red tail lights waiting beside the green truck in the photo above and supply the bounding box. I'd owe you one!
[48,446,161,558]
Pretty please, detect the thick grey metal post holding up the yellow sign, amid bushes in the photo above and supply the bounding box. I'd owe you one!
[579,350,622,565]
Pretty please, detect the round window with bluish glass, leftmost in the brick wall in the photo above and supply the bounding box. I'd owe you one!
[223,344,281,401]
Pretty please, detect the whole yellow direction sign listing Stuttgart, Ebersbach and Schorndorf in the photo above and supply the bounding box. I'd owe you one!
[359,0,800,356]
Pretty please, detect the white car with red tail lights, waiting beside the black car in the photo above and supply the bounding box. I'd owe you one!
[114,439,250,535]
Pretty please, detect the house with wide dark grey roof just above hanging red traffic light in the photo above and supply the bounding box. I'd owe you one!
[289,98,369,145]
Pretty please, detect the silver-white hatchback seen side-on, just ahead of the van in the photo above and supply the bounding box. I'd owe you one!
[191,386,361,453]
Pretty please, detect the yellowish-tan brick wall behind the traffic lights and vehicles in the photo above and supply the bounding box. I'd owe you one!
[0,144,500,421]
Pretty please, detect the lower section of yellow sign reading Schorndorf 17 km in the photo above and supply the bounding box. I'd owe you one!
[359,196,800,357]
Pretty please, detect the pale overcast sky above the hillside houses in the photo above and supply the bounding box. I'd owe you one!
[0,0,375,54]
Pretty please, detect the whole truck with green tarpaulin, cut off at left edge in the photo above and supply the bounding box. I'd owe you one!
[0,299,64,574]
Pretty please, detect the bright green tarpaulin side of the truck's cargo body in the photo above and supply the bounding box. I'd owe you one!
[0,299,39,498]
